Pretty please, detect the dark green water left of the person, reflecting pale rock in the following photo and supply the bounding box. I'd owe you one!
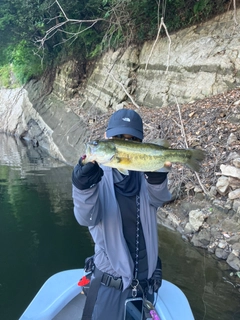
[0,135,93,320]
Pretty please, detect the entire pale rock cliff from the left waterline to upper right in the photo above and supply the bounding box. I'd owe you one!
[0,10,240,164]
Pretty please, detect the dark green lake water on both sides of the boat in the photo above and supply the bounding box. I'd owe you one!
[0,134,240,320]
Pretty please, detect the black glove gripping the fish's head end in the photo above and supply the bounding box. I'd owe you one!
[72,158,103,190]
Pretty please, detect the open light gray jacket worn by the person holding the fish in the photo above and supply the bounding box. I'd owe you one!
[73,166,171,289]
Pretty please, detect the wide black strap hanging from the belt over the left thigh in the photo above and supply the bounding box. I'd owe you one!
[82,267,102,320]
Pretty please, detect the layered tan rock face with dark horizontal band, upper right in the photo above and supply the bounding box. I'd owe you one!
[79,12,240,110]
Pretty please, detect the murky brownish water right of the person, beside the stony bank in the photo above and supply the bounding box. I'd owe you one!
[159,226,240,320]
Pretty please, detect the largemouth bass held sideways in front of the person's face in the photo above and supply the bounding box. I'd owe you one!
[84,139,205,174]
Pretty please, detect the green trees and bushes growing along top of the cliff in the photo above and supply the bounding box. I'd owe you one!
[0,0,232,87]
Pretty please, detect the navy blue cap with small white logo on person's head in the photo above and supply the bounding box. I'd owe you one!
[106,109,143,140]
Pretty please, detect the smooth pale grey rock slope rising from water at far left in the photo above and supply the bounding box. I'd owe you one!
[0,81,88,164]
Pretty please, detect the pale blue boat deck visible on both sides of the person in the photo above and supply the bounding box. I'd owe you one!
[19,269,194,320]
